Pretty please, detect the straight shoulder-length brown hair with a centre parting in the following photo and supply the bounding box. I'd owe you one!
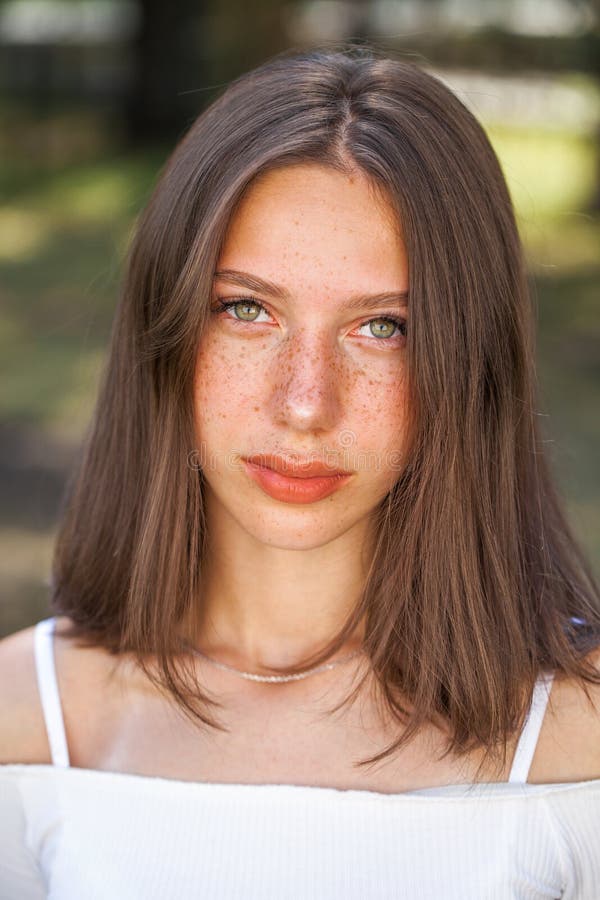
[51,45,600,765]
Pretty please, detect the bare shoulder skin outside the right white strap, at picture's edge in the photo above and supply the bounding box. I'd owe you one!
[529,648,600,783]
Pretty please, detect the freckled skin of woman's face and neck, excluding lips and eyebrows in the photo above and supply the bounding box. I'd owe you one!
[195,164,408,671]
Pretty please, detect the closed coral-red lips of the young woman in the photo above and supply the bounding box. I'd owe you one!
[243,456,352,503]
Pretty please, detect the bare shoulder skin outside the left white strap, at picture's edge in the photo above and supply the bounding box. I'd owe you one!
[0,627,51,764]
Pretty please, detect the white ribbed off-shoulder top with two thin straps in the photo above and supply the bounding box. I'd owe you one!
[0,619,600,900]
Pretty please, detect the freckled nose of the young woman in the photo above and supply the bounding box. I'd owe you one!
[271,330,344,432]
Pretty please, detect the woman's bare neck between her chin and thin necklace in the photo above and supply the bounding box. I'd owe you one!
[190,502,376,672]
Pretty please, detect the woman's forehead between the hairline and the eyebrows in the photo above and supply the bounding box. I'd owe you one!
[217,164,408,292]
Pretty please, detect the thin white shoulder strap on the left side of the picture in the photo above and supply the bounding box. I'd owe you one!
[34,617,69,768]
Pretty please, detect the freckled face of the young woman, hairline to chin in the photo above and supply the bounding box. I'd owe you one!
[194,164,408,549]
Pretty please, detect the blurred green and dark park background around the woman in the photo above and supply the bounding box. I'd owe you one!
[0,0,600,635]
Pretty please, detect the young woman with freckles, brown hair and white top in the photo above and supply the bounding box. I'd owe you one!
[0,47,600,900]
